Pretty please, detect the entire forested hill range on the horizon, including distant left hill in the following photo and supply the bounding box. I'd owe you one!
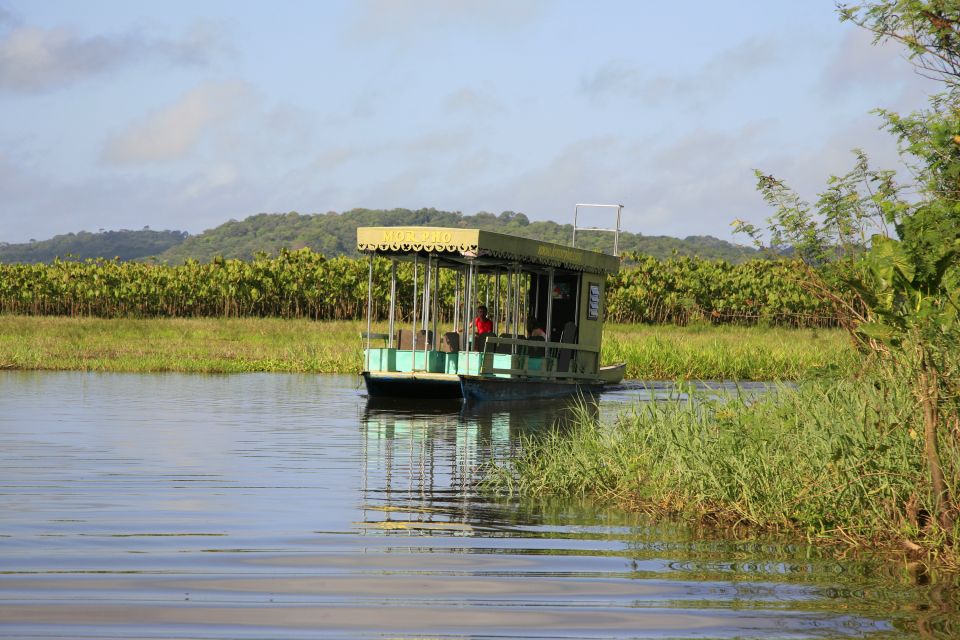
[0,209,756,264]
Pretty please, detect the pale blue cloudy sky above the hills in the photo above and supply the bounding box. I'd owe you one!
[0,0,935,242]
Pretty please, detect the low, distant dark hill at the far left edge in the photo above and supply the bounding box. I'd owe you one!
[0,229,187,262]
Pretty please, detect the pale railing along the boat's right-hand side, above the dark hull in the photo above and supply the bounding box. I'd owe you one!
[479,336,600,378]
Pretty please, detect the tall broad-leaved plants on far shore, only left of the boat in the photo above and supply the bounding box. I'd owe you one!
[0,249,372,319]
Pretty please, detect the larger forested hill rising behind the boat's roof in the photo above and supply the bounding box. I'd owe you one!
[157,209,756,264]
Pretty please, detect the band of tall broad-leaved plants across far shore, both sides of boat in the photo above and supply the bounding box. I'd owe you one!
[0,249,835,327]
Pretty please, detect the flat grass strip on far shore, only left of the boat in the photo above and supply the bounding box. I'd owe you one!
[0,316,366,373]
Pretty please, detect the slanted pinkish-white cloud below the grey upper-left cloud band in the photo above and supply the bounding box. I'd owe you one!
[101,82,252,165]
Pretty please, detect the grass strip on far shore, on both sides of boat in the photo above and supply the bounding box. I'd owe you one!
[0,315,856,380]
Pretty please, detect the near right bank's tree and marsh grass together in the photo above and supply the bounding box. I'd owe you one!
[488,0,960,568]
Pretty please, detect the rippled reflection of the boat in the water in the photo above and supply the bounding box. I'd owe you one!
[356,398,599,535]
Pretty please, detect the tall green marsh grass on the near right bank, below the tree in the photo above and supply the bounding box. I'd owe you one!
[483,380,960,564]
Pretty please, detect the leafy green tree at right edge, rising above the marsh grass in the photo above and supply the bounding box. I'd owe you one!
[736,0,960,529]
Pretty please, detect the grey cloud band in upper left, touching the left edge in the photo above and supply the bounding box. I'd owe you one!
[0,22,220,93]
